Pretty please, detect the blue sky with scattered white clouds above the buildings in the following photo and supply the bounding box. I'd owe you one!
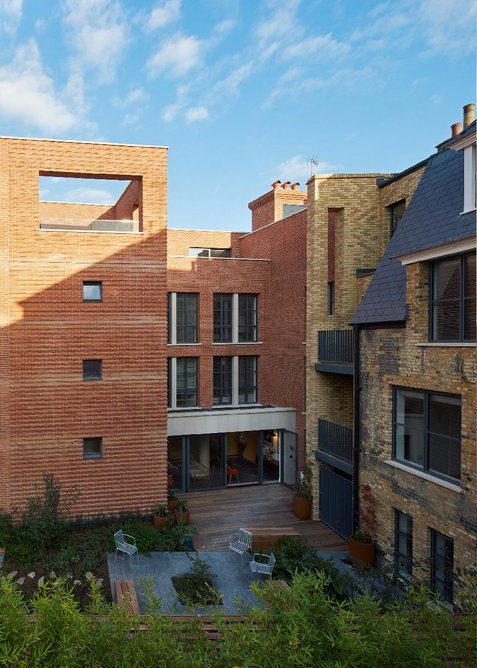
[0,0,477,231]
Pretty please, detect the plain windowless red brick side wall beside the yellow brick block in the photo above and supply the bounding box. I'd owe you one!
[240,210,306,466]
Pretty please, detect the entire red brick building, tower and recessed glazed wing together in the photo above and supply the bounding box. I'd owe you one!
[0,138,306,515]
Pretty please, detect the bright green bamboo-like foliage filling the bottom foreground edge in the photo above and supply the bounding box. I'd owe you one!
[0,566,476,668]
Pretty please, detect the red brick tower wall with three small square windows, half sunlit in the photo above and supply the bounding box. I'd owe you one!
[0,139,167,514]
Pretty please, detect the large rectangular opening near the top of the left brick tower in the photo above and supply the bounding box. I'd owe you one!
[39,172,142,232]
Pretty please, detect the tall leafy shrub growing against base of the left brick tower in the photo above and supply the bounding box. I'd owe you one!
[22,473,79,549]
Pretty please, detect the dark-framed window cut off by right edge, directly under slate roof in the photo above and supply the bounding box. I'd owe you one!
[429,253,475,341]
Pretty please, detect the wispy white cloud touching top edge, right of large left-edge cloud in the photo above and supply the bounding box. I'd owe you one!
[63,0,129,81]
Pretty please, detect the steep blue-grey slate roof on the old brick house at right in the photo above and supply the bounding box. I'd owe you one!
[351,150,475,325]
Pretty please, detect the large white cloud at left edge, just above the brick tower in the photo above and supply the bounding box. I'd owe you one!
[0,40,79,135]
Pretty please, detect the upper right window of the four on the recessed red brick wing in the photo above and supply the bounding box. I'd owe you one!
[214,293,258,343]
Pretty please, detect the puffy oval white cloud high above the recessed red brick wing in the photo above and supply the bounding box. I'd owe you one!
[147,34,203,77]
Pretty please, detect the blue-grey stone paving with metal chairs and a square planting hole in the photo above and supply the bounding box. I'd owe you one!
[108,550,261,615]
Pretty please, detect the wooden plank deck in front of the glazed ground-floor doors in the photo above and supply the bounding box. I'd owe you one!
[184,484,348,552]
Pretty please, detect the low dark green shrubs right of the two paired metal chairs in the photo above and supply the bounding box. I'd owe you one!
[273,536,351,599]
